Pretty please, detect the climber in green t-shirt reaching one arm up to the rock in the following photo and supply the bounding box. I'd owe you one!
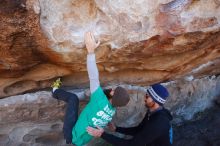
[52,32,129,146]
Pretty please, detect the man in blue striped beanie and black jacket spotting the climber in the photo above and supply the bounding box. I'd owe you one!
[87,84,172,146]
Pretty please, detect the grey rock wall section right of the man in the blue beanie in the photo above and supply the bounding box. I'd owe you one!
[167,76,220,124]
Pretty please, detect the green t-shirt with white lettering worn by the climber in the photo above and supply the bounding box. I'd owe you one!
[72,86,115,146]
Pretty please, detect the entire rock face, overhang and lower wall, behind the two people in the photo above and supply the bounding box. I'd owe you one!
[0,0,220,146]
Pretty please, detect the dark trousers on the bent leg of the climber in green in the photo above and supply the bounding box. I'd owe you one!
[53,89,79,144]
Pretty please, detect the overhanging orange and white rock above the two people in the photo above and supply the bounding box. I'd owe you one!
[0,0,220,97]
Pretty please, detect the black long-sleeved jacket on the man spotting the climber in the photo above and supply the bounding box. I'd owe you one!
[102,108,172,146]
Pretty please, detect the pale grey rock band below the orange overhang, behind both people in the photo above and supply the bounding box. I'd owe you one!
[0,76,220,125]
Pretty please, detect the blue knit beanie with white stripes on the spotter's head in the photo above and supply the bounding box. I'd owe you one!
[147,84,169,105]
